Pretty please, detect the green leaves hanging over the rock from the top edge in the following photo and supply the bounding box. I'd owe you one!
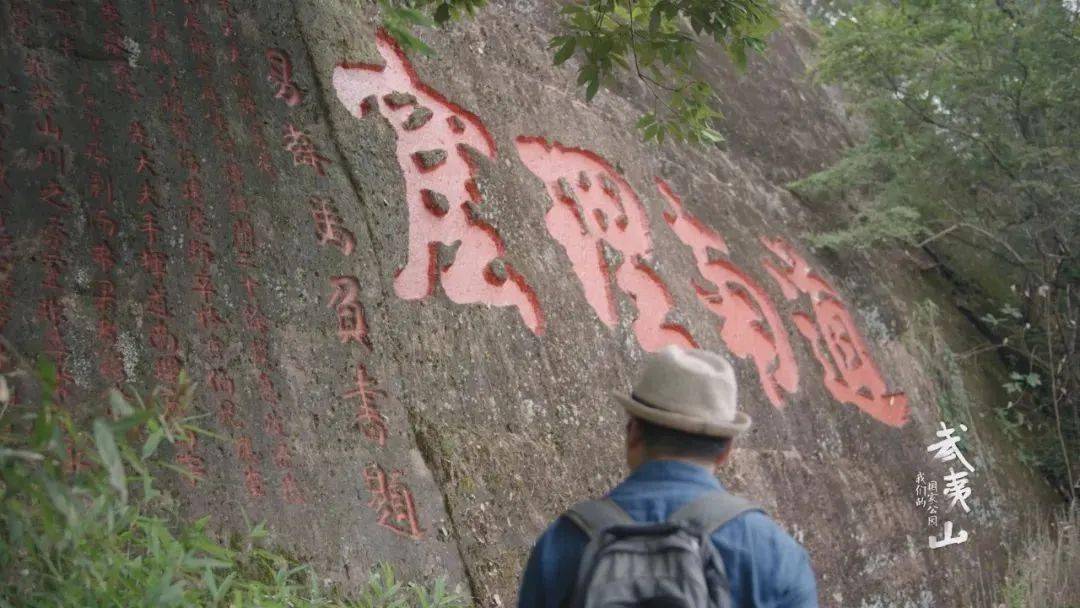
[382,0,779,144]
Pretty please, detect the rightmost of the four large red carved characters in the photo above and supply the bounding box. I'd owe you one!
[761,239,908,427]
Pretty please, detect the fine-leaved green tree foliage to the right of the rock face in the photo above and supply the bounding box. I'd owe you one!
[791,0,1080,495]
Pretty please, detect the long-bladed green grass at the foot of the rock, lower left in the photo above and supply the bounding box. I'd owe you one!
[0,376,470,608]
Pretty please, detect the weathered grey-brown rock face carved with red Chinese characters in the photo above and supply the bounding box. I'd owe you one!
[0,0,1058,606]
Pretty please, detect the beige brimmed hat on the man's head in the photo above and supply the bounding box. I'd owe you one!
[613,346,751,437]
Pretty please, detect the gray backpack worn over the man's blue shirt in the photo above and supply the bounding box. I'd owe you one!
[566,491,760,608]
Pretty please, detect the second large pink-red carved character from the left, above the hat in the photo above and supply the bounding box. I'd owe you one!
[516,137,696,351]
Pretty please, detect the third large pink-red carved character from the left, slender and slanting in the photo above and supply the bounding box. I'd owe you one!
[657,178,799,407]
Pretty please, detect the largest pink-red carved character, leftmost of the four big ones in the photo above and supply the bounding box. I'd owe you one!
[334,31,543,335]
